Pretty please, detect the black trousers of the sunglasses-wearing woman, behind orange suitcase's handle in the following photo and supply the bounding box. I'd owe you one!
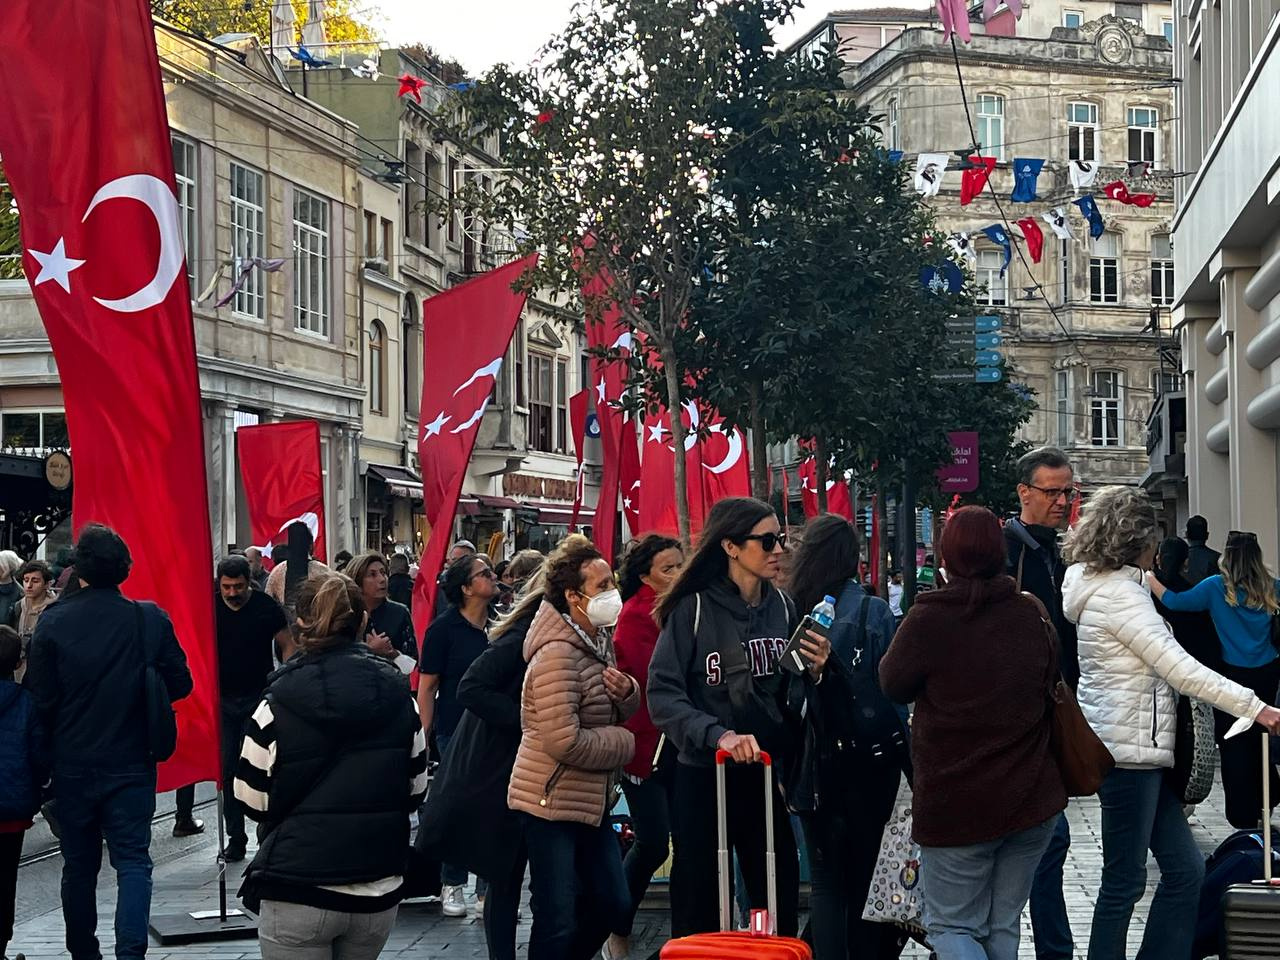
[671,763,800,937]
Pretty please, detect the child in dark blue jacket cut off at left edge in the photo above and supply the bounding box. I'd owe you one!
[0,626,49,960]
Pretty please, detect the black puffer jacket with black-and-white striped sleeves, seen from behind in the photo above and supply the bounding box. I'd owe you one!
[244,643,425,909]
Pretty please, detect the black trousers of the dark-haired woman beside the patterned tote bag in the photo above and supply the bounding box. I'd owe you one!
[801,765,908,960]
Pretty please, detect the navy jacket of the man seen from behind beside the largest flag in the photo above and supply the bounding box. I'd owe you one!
[23,586,192,771]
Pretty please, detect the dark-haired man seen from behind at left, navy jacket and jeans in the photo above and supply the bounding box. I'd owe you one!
[24,524,192,960]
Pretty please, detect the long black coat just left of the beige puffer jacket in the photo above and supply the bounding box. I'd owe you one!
[417,613,534,881]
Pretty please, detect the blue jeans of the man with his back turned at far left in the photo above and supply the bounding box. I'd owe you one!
[54,764,156,960]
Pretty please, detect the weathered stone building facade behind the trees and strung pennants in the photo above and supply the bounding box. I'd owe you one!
[833,11,1178,490]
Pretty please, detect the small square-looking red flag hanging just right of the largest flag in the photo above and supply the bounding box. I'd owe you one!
[236,420,329,563]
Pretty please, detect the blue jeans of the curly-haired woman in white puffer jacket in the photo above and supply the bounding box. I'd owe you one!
[1089,768,1204,960]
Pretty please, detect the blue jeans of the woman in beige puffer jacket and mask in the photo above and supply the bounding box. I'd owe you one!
[520,813,631,960]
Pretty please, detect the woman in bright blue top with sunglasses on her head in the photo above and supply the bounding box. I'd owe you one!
[1147,530,1280,829]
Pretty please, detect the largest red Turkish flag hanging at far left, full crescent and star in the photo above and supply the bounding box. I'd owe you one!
[0,0,221,791]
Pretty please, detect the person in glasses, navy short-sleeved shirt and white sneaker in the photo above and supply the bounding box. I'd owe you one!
[417,553,498,916]
